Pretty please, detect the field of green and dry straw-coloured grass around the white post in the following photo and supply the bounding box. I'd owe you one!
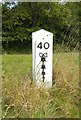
[2,53,80,118]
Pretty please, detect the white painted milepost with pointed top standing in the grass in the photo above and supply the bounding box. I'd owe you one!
[32,29,53,87]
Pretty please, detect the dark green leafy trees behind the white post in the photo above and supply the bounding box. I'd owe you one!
[2,2,81,49]
